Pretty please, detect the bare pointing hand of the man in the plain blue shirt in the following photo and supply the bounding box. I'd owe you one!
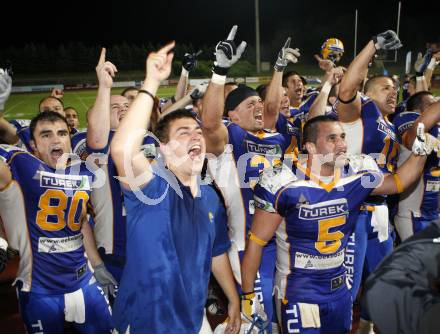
[145,41,175,84]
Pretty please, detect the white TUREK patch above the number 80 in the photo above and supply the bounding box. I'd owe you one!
[39,171,90,190]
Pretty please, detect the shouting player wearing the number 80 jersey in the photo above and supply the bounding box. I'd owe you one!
[0,111,116,333]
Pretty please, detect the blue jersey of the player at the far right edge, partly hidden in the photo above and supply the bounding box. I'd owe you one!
[394,111,440,221]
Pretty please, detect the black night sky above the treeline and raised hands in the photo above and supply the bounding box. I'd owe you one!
[0,0,440,59]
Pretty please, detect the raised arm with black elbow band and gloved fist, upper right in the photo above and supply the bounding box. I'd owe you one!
[337,30,402,122]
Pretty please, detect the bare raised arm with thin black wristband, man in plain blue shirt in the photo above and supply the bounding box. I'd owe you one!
[110,42,174,187]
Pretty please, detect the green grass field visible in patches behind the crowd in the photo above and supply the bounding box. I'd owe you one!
[3,85,440,127]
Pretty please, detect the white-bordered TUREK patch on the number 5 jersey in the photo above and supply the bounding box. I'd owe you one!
[298,198,348,220]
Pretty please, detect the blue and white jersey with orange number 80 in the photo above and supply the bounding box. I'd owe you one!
[0,146,93,294]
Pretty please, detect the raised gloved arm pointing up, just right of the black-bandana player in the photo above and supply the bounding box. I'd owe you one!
[264,37,300,129]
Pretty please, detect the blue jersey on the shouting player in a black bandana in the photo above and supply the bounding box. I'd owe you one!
[227,120,297,229]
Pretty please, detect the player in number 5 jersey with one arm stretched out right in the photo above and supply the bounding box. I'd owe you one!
[242,116,432,334]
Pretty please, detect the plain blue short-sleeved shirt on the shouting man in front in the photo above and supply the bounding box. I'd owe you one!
[113,167,230,334]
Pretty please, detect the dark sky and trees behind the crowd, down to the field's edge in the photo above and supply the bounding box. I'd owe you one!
[0,0,440,72]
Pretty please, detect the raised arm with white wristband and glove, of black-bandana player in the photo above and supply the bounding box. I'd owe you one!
[202,26,246,155]
